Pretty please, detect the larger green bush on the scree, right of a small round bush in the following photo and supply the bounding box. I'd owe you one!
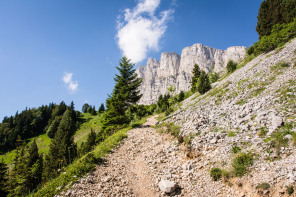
[232,153,254,177]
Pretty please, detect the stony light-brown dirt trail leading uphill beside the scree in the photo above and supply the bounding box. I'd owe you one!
[64,117,177,197]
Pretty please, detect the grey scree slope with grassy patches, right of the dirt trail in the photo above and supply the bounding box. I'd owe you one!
[165,39,296,196]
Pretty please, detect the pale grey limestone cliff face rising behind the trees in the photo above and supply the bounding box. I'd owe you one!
[136,44,246,104]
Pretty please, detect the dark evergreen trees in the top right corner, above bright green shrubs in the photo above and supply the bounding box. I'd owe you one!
[256,0,296,39]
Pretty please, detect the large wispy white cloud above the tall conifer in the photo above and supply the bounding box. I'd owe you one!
[117,0,173,63]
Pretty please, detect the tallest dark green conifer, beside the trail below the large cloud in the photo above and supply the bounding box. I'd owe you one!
[102,57,142,131]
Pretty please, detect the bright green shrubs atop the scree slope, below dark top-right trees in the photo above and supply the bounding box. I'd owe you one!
[253,18,296,55]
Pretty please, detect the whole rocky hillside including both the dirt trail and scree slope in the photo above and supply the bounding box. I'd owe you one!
[61,39,296,196]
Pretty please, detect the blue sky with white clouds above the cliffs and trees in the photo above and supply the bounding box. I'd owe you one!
[0,0,261,121]
